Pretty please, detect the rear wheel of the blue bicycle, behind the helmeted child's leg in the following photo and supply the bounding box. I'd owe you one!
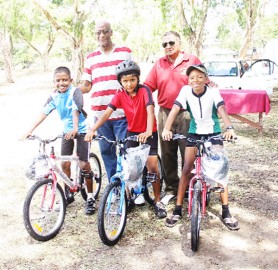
[143,155,164,205]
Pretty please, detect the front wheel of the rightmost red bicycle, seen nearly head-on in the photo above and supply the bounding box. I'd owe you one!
[191,182,202,251]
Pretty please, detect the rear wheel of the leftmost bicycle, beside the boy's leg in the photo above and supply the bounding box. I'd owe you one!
[80,153,102,201]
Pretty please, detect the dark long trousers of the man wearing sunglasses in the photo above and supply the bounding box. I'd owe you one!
[158,107,190,195]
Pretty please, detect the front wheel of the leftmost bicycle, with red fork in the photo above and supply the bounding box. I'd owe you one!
[23,178,66,241]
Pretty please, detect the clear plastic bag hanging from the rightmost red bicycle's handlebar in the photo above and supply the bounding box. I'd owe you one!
[202,145,229,187]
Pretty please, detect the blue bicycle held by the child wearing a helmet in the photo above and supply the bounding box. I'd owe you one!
[94,136,163,246]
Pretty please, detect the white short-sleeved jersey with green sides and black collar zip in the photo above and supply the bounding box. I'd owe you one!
[175,85,224,135]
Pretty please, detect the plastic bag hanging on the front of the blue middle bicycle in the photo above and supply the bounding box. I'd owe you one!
[123,144,151,181]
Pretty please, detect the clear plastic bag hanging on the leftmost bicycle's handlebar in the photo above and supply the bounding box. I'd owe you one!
[25,154,49,180]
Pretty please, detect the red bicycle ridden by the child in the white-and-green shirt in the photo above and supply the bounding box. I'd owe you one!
[172,134,231,252]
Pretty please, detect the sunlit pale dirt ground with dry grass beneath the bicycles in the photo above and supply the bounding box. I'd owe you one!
[0,68,278,270]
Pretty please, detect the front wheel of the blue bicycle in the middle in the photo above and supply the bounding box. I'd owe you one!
[98,179,127,246]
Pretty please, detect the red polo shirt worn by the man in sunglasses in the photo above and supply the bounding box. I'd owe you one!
[144,52,201,109]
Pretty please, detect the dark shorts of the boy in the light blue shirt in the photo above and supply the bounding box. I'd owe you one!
[61,133,89,161]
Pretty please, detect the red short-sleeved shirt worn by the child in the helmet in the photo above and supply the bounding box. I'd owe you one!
[108,84,157,133]
